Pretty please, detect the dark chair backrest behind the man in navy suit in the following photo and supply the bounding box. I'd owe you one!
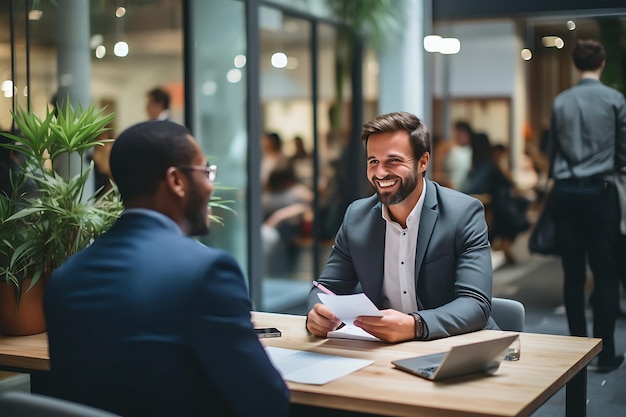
[0,391,119,417]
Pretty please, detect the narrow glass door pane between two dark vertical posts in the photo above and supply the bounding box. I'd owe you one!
[258,7,316,311]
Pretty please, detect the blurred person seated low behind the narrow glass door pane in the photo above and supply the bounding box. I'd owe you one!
[261,164,313,274]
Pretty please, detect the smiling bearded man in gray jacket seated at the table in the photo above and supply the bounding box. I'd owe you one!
[307,112,497,342]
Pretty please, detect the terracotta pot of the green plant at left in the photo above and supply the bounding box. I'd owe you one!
[0,279,46,336]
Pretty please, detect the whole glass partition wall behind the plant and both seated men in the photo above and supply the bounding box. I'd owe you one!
[0,0,361,311]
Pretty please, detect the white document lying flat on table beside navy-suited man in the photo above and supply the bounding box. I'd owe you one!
[265,346,374,385]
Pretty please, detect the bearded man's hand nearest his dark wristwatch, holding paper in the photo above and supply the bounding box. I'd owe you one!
[354,309,415,343]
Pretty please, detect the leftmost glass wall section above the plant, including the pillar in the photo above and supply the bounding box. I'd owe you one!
[0,0,184,192]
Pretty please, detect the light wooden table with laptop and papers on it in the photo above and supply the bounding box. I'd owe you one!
[0,312,602,417]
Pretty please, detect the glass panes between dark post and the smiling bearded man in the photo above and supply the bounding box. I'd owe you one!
[254,6,357,311]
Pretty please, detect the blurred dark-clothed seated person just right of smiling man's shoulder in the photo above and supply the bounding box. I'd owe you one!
[462,133,530,262]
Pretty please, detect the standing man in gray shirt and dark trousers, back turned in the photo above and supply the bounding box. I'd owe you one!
[548,40,626,372]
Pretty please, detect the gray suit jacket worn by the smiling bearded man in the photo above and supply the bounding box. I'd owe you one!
[308,180,497,340]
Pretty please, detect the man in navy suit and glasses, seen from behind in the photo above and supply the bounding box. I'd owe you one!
[44,121,289,417]
